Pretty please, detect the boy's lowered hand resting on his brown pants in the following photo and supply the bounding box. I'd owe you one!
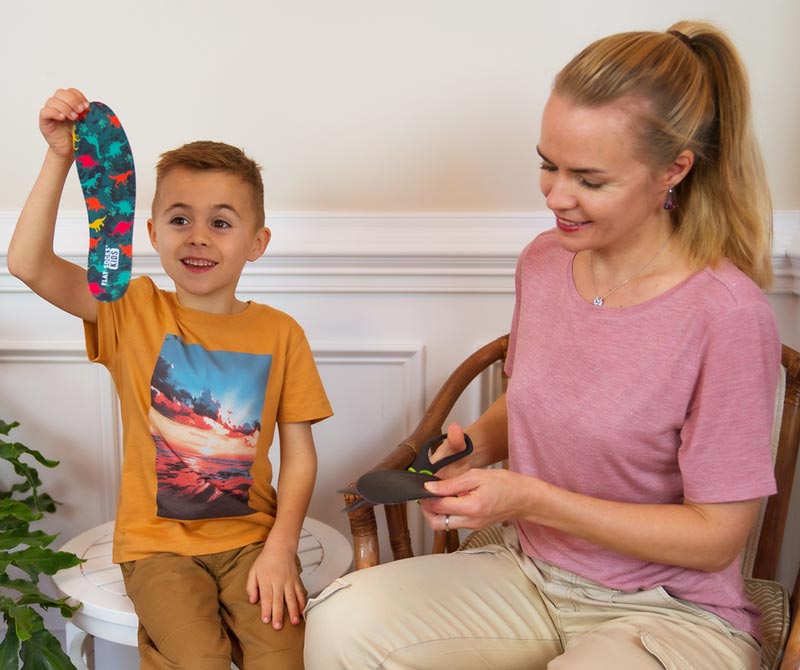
[247,538,306,630]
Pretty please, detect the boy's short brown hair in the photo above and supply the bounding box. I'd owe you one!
[153,140,265,228]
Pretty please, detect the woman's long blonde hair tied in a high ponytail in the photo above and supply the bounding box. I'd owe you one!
[553,21,772,288]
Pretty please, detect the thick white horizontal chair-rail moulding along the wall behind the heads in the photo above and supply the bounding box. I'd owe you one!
[0,210,800,295]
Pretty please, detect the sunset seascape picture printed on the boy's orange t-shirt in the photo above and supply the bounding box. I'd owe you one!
[150,335,272,520]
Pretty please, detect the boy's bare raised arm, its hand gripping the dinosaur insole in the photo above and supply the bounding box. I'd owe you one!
[8,89,97,322]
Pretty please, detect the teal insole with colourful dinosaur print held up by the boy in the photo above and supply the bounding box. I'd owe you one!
[72,102,136,302]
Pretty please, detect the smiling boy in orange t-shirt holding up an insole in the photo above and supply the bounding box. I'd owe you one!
[8,89,331,670]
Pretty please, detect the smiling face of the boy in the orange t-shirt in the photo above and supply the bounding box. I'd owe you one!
[147,167,270,314]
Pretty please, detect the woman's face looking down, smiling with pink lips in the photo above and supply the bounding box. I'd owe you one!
[537,93,671,254]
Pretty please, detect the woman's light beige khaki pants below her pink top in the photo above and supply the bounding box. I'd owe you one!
[305,528,760,670]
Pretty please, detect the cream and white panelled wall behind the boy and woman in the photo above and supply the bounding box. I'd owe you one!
[0,0,800,668]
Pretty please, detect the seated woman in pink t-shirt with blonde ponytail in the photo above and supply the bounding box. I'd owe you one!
[306,22,780,670]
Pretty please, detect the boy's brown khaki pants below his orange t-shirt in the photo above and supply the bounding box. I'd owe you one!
[121,543,305,670]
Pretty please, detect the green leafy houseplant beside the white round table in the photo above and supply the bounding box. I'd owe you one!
[0,419,81,670]
